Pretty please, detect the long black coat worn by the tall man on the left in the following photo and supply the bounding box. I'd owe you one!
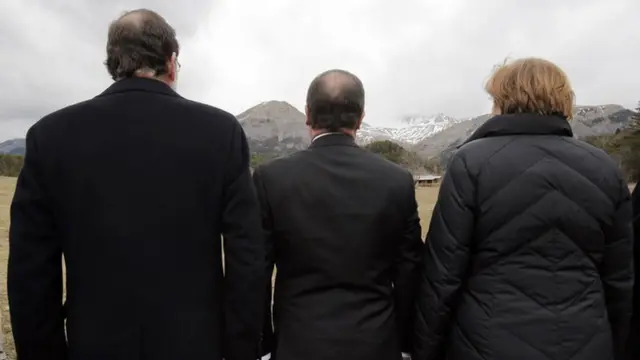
[8,78,265,360]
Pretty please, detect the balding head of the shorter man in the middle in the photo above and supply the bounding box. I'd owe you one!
[305,70,364,137]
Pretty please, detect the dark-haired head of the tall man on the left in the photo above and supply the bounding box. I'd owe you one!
[105,9,180,88]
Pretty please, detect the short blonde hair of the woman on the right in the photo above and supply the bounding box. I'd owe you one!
[484,58,575,120]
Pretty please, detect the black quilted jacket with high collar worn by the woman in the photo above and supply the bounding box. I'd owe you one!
[413,114,633,360]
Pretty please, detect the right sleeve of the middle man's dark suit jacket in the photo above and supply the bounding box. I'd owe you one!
[393,174,423,353]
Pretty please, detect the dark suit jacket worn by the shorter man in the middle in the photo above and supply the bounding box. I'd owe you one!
[253,134,422,360]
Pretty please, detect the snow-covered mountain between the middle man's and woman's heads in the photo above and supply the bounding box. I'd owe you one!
[358,113,468,145]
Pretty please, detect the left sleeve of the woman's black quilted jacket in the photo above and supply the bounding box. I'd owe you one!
[412,153,476,360]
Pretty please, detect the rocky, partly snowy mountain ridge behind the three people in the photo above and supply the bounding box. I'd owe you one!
[0,100,634,158]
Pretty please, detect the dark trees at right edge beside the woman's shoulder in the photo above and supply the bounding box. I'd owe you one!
[584,102,640,182]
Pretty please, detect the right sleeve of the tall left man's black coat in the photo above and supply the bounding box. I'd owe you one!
[222,121,265,360]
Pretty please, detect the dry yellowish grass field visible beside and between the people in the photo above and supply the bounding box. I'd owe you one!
[0,177,438,359]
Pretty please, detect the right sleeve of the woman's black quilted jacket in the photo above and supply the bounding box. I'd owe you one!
[601,181,634,359]
